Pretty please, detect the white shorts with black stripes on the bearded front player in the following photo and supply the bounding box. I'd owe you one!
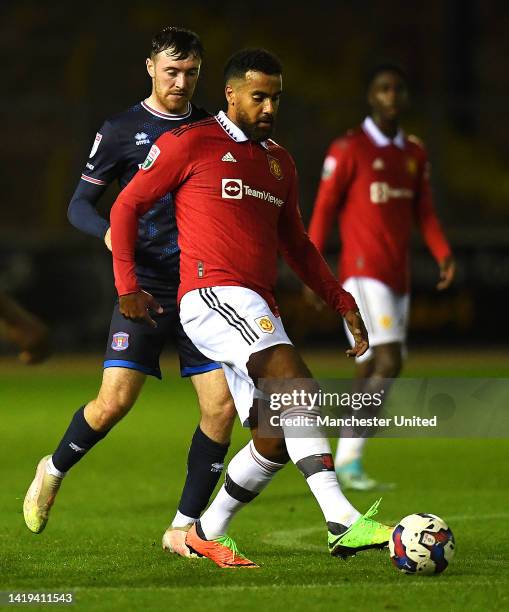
[180,287,292,426]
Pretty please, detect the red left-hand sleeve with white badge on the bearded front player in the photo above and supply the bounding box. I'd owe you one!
[110,133,189,295]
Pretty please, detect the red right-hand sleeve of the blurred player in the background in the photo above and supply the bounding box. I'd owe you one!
[415,161,451,262]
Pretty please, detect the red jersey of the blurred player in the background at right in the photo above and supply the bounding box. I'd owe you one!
[309,117,451,293]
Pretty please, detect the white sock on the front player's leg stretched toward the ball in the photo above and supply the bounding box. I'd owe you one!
[283,409,360,525]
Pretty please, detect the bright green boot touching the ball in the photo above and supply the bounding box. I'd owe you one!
[328,499,394,559]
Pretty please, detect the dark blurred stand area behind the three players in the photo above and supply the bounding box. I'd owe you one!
[0,0,509,350]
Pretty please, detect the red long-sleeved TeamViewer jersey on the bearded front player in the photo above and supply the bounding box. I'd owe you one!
[110,112,357,314]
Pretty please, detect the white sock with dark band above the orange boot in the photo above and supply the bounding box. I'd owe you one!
[200,440,285,540]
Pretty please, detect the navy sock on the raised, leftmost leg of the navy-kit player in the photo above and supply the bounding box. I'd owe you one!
[51,406,109,472]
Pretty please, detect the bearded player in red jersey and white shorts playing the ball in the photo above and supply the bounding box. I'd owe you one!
[111,49,391,567]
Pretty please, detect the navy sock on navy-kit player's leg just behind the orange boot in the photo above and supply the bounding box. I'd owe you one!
[176,426,229,527]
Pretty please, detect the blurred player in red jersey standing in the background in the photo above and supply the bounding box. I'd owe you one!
[309,64,455,490]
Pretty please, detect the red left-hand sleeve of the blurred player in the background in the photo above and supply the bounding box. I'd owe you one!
[309,140,354,253]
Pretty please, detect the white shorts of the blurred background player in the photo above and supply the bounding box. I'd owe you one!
[343,276,410,362]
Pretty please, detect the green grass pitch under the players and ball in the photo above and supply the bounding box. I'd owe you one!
[0,354,509,612]
